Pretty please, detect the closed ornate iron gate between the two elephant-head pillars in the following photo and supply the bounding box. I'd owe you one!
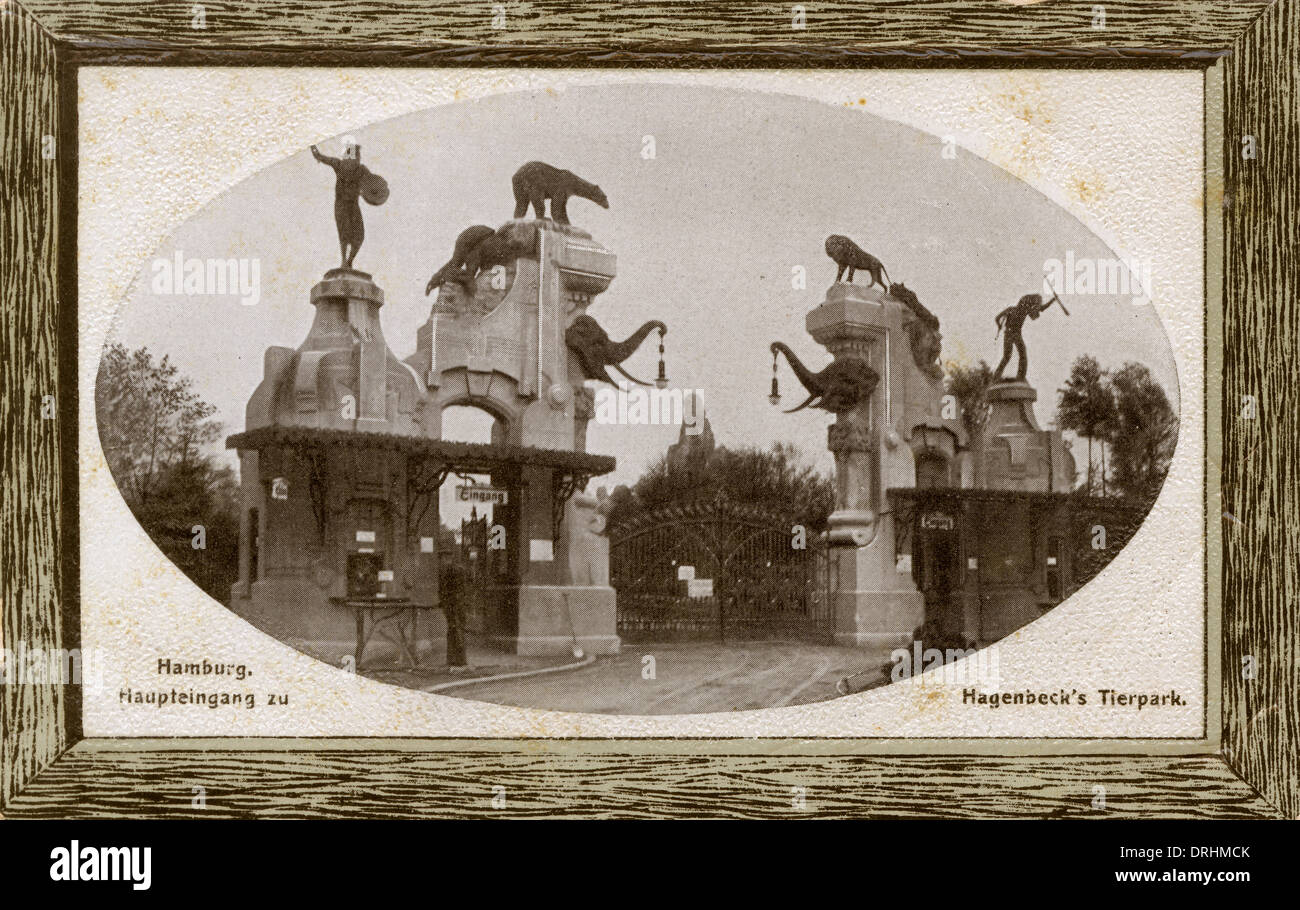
[610,502,833,642]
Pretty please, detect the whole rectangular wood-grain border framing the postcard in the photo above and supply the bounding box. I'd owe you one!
[0,0,1300,818]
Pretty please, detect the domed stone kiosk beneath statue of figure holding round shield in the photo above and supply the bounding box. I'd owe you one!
[228,269,443,647]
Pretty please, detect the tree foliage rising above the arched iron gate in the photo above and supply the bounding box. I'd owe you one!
[608,442,835,530]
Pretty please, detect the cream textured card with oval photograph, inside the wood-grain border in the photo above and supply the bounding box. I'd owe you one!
[77,66,1219,753]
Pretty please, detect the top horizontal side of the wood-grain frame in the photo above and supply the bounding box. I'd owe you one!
[25,0,1269,60]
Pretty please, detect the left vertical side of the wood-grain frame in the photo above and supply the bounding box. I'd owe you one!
[0,0,68,806]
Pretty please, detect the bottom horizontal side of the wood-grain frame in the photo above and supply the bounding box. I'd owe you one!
[7,741,1275,819]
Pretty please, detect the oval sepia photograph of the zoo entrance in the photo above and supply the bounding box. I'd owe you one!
[95,83,1179,715]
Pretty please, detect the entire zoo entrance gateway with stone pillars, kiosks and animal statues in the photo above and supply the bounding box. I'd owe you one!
[228,150,1123,658]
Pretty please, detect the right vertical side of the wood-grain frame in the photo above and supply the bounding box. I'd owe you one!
[1223,0,1300,818]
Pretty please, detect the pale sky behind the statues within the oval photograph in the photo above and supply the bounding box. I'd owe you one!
[101,85,1178,512]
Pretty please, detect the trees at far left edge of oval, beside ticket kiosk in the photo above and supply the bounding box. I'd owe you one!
[95,343,239,602]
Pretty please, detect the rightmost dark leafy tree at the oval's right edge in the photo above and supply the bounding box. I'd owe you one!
[1110,363,1178,504]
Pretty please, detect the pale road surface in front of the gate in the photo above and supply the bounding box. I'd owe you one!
[345,642,888,714]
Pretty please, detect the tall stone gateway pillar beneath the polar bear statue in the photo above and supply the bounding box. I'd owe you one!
[406,220,619,655]
